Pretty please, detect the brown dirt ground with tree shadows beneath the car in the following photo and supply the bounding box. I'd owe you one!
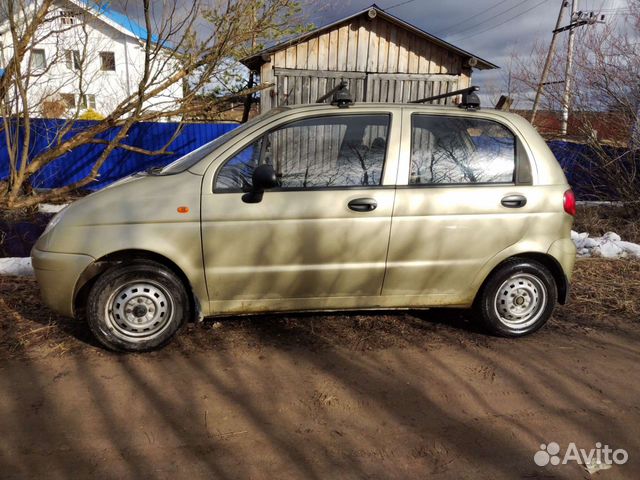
[0,260,640,479]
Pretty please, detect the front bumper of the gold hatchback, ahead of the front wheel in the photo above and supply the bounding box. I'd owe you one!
[31,248,95,317]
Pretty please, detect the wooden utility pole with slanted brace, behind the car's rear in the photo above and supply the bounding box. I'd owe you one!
[531,0,604,136]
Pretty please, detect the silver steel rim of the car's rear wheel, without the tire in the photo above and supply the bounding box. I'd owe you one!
[495,273,547,330]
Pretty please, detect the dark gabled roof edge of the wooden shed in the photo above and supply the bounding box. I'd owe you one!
[241,3,500,70]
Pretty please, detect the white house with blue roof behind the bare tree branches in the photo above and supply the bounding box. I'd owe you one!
[0,0,182,116]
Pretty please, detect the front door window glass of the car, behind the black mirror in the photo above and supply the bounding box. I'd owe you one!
[215,114,390,191]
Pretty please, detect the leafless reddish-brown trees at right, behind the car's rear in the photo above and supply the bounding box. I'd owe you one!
[515,0,640,202]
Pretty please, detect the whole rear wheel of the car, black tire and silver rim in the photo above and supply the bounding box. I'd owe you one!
[475,259,558,337]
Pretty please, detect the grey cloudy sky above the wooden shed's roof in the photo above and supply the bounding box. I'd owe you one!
[305,0,628,104]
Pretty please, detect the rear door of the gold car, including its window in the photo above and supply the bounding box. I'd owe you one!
[383,109,543,303]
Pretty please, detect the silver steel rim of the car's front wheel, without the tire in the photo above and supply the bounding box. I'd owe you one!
[105,281,173,342]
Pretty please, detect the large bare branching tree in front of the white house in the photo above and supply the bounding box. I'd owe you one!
[0,0,303,209]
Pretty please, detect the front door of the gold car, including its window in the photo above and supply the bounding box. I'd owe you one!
[202,111,398,313]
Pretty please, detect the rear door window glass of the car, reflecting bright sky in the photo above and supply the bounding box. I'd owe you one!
[409,115,516,185]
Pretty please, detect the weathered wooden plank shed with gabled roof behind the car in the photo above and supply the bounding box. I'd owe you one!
[242,5,498,112]
